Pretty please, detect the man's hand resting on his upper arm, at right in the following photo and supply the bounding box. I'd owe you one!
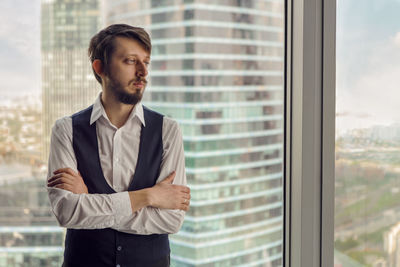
[149,172,190,211]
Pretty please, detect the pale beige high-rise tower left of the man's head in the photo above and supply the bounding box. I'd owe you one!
[41,0,101,162]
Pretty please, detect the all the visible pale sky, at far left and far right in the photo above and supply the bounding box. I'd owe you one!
[0,0,400,133]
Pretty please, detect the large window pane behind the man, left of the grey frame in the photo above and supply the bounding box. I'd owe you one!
[0,0,285,267]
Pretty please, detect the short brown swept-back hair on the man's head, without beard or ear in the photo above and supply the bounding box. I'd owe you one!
[88,24,151,84]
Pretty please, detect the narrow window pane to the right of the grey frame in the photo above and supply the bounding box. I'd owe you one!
[335,0,400,267]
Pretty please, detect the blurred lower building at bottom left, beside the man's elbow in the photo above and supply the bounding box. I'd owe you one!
[0,164,64,267]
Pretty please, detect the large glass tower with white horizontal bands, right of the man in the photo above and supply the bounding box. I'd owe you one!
[105,0,285,266]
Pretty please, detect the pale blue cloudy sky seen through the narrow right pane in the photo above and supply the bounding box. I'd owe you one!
[336,0,400,134]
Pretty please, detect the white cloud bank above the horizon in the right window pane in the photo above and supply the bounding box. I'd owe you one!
[336,32,400,134]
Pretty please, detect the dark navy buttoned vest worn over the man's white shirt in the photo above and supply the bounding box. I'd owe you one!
[64,106,170,267]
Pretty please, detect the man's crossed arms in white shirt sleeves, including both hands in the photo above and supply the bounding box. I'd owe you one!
[47,117,190,234]
